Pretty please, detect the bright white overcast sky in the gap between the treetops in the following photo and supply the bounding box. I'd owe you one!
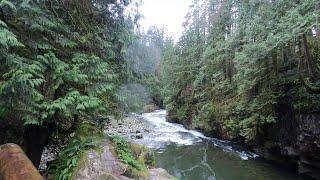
[140,0,192,41]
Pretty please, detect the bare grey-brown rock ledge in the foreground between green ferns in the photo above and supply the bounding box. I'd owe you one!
[72,139,174,180]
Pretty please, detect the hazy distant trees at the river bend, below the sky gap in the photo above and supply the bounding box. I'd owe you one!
[119,27,166,109]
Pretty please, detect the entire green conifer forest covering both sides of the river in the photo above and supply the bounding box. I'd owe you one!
[0,0,320,179]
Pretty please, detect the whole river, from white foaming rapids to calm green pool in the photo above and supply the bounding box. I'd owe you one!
[133,110,301,180]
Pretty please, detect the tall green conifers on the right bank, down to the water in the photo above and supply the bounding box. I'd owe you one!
[162,0,320,177]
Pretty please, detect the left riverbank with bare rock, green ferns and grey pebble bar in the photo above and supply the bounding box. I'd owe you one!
[40,114,174,180]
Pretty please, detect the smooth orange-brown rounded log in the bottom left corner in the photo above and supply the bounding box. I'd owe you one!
[0,144,43,180]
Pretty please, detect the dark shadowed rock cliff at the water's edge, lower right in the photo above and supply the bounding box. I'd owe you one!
[253,112,320,179]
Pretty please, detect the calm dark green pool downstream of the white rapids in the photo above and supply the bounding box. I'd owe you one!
[157,141,299,180]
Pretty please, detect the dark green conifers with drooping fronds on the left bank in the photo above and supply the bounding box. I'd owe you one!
[0,0,138,169]
